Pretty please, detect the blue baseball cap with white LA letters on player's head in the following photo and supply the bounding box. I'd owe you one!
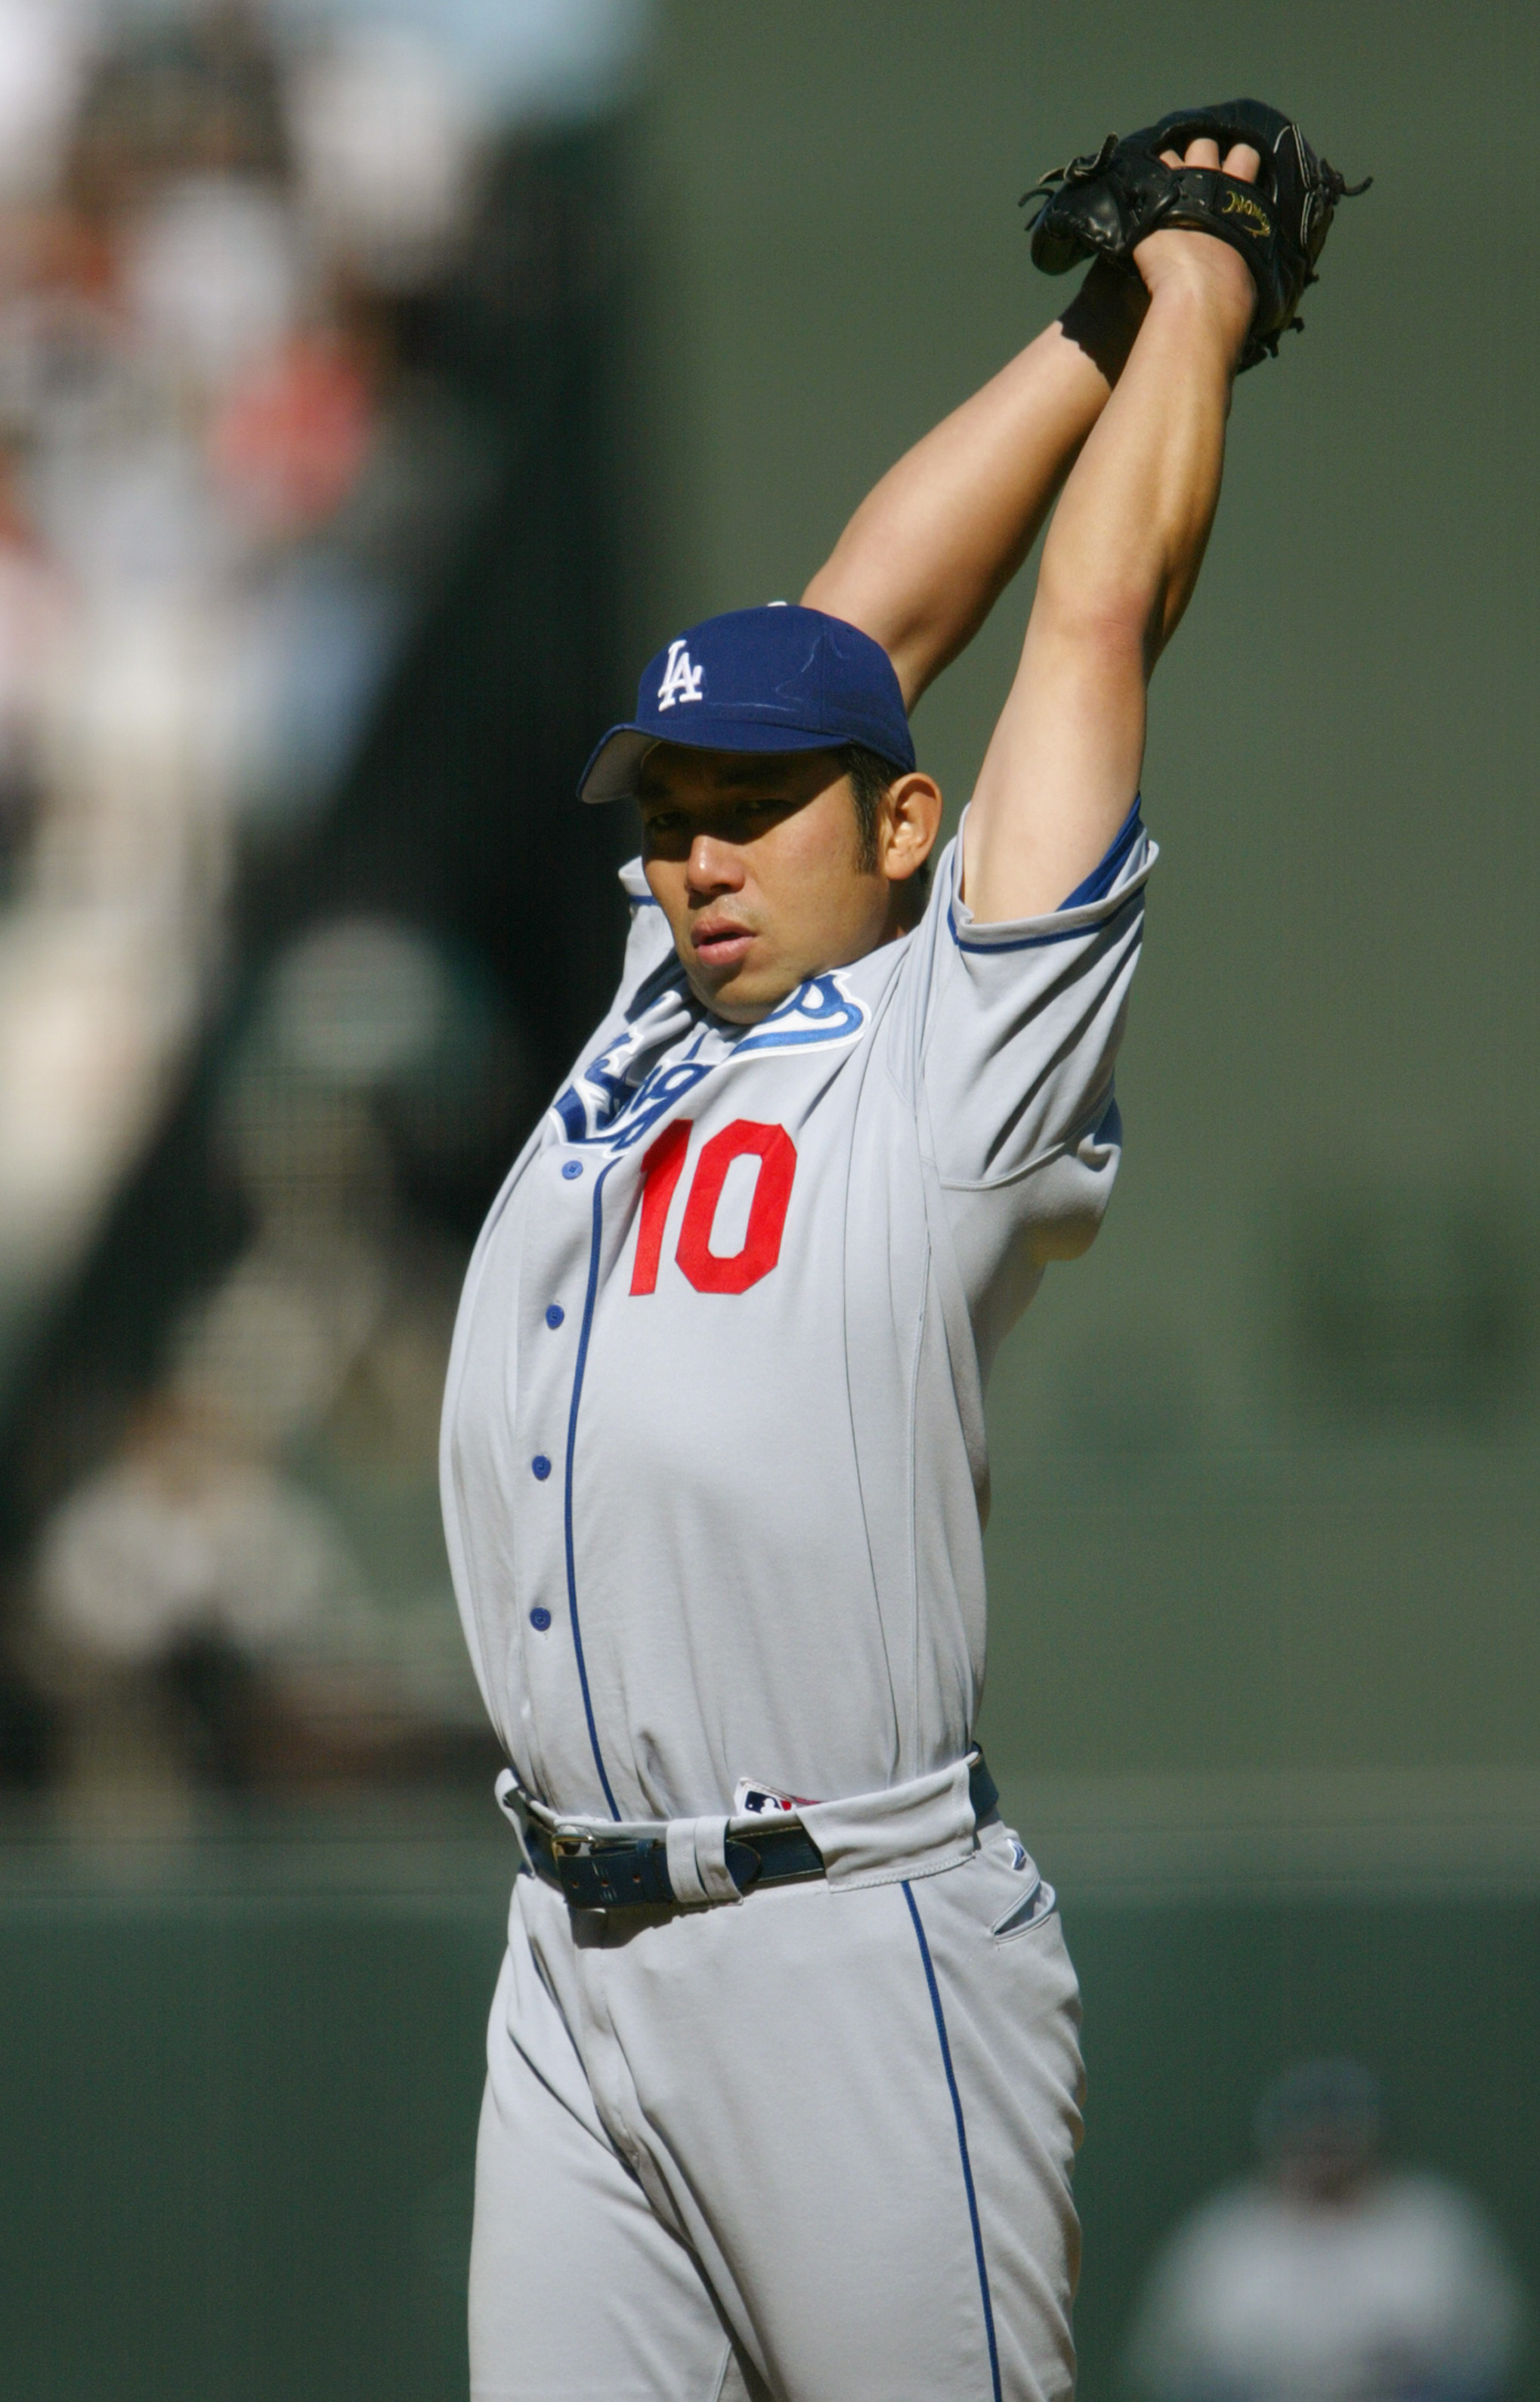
[577,601,915,800]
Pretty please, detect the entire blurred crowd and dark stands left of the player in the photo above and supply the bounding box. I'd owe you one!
[0,0,644,1794]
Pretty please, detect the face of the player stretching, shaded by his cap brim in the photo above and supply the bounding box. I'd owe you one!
[637,742,894,1026]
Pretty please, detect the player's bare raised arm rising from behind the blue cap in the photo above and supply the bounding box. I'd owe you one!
[802,269,1143,709]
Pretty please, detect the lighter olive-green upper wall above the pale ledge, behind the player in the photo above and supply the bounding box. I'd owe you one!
[637,0,1540,1772]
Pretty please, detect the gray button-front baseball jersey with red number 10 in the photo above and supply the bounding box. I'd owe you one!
[444,814,1155,1819]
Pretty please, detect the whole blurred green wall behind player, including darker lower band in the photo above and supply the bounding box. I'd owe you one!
[0,0,1540,2402]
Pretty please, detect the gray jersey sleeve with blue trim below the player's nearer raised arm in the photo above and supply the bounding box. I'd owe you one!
[906,805,1155,1357]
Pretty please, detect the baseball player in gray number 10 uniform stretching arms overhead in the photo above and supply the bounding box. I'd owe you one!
[444,104,1341,2402]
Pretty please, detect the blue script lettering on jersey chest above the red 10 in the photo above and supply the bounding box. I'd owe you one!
[552,973,867,1150]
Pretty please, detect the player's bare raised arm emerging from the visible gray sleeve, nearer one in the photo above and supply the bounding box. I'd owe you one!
[963,251,1249,920]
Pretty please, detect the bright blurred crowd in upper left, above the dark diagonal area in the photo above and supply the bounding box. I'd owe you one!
[0,0,509,1343]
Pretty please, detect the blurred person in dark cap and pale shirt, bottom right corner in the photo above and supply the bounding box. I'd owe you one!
[1129,2061,1523,2402]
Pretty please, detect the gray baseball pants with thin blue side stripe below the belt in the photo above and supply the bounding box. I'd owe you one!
[471,1821,1081,2402]
